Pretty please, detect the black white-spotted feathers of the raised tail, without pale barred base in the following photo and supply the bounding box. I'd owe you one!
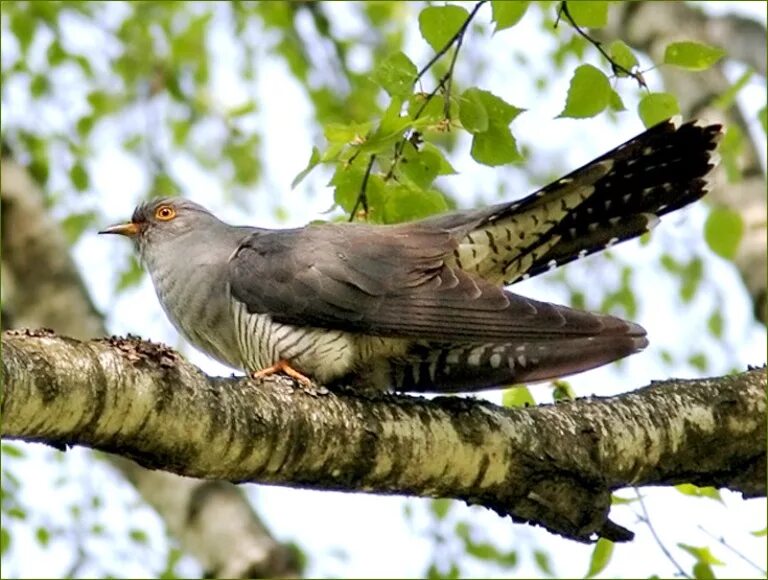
[493,118,722,283]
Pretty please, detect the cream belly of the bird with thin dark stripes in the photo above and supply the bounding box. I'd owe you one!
[232,301,358,384]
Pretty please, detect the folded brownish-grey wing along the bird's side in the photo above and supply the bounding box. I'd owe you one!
[229,223,644,342]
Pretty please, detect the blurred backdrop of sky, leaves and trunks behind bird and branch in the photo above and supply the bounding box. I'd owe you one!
[0,2,766,578]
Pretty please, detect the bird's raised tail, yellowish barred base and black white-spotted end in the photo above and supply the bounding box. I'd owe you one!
[430,119,722,284]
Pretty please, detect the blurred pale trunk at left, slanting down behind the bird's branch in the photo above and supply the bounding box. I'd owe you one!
[0,158,299,578]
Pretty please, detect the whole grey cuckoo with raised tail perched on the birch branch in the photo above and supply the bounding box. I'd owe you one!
[99,118,722,393]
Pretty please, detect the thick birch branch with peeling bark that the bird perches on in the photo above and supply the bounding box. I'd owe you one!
[2,331,766,541]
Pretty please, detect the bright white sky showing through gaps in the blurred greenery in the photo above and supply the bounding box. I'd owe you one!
[2,2,766,577]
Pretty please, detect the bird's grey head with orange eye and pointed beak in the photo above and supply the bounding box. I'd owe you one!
[99,197,221,254]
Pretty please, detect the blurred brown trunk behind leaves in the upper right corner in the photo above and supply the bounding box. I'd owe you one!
[601,2,768,324]
